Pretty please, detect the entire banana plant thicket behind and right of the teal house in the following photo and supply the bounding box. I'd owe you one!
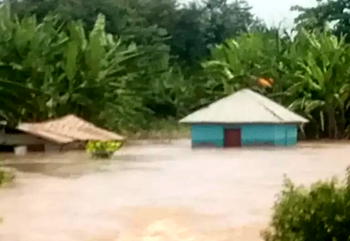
[204,30,350,138]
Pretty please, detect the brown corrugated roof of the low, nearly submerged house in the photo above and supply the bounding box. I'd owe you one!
[17,115,124,144]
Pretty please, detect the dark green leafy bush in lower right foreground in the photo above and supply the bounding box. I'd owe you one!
[263,170,350,241]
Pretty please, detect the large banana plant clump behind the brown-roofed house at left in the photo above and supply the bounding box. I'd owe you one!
[0,4,168,131]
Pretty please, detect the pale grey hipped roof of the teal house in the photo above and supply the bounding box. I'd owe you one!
[180,89,308,124]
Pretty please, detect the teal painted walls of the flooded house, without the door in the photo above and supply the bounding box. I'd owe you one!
[192,124,298,147]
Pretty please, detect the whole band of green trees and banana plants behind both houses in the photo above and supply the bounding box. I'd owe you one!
[0,0,350,138]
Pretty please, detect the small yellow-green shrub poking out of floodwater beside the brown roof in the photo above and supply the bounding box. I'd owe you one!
[86,141,123,159]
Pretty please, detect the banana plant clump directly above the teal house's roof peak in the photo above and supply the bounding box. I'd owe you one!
[203,31,284,95]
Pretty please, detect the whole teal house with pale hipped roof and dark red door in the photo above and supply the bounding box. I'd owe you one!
[180,89,308,147]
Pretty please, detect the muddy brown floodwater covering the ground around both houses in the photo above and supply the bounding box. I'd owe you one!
[0,141,350,241]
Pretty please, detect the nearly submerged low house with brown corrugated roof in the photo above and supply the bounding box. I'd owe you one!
[0,115,124,153]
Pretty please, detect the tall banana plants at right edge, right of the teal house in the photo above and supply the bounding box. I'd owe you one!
[287,31,350,138]
